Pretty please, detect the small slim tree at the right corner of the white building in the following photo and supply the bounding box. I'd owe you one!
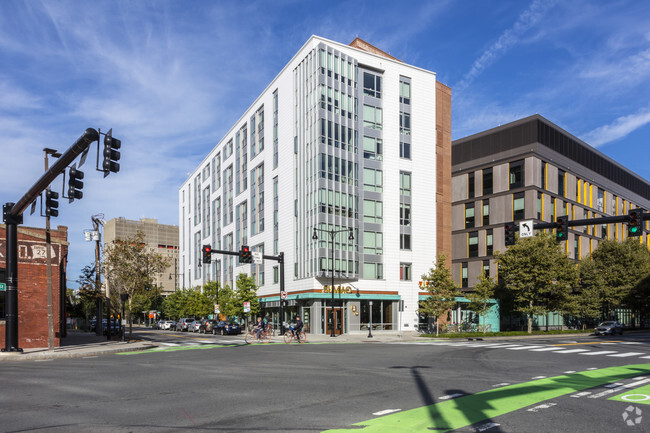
[419,254,459,335]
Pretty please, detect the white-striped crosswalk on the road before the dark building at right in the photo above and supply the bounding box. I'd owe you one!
[395,341,650,359]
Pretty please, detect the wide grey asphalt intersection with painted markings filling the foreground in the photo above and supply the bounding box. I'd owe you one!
[0,333,650,433]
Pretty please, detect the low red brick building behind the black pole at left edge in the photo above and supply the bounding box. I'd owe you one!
[0,224,68,349]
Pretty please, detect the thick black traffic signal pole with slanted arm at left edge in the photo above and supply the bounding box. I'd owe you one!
[2,128,99,352]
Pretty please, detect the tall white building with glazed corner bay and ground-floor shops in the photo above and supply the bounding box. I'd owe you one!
[179,36,451,333]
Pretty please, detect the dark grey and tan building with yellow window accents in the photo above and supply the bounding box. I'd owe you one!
[452,115,650,326]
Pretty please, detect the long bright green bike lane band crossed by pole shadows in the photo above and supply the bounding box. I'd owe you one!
[323,364,650,433]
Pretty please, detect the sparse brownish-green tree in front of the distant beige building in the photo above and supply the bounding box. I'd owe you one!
[104,231,170,336]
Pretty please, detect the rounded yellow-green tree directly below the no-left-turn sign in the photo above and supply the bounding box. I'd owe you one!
[496,233,578,334]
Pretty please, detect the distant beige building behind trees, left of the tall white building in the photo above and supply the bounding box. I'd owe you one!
[104,217,180,296]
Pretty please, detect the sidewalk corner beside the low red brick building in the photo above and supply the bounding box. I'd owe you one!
[0,330,157,362]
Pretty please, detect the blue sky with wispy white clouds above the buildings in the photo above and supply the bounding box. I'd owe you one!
[0,0,650,287]
